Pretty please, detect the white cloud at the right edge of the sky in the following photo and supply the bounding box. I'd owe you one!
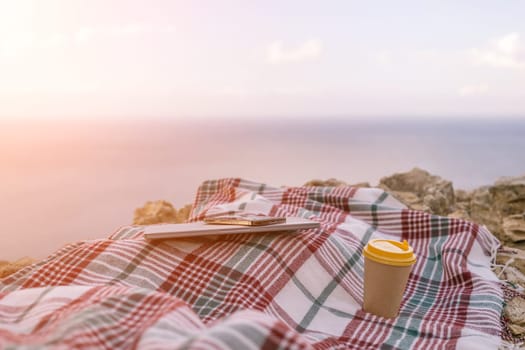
[470,32,525,69]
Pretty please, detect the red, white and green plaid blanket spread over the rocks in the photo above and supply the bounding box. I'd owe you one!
[0,179,503,349]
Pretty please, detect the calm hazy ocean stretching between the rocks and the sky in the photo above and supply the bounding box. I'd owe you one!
[0,118,525,260]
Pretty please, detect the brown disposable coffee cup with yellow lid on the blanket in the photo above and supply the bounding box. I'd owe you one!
[363,239,416,318]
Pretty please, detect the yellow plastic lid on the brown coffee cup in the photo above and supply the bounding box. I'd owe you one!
[363,239,416,266]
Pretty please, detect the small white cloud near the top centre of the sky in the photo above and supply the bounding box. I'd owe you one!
[266,39,323,64]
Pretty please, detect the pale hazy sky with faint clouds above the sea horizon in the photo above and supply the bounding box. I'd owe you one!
[0,0,525,120]
